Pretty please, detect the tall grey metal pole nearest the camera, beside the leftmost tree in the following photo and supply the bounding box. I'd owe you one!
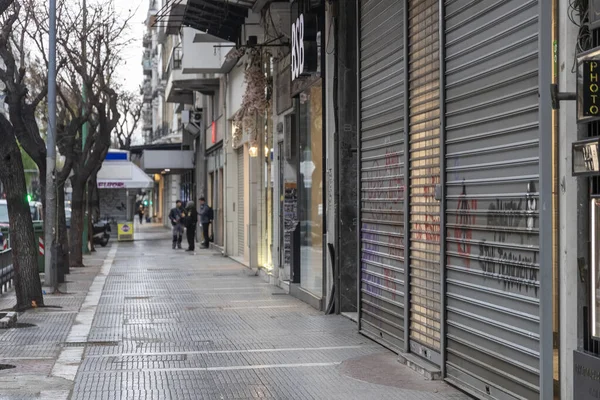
[44,0,57,287]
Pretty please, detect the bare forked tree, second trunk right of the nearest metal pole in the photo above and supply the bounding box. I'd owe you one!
[59,0,131,267]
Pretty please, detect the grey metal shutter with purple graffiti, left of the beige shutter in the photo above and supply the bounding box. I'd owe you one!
[359,0,404,351]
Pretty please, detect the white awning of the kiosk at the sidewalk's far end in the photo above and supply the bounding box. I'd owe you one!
[98,161,154,189]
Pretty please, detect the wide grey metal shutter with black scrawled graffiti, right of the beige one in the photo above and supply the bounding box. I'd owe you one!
[444,0,540,399]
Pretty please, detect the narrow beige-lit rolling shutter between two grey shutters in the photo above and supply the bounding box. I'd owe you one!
[408,0,441,365]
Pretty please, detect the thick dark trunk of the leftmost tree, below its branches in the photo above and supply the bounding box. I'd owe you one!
[0,125,43,310]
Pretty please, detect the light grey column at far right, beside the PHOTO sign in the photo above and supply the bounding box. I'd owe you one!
[558,1,589,400]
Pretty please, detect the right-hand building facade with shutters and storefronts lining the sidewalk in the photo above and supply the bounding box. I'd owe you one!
[139,0,600,399]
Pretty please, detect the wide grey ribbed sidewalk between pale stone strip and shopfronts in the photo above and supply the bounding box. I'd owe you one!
[62,227,468,400]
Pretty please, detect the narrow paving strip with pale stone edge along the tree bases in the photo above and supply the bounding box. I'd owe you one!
[0,242,109,400]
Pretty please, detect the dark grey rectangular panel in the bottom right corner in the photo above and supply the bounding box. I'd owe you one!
[573,350,600,400]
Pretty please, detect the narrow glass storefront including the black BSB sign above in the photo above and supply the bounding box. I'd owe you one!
[290,1,326,308]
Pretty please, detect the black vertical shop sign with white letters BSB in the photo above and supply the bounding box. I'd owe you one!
[290,14,319,81]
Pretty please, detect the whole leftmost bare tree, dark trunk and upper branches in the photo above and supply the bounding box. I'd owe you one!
[0,0,45,310]
